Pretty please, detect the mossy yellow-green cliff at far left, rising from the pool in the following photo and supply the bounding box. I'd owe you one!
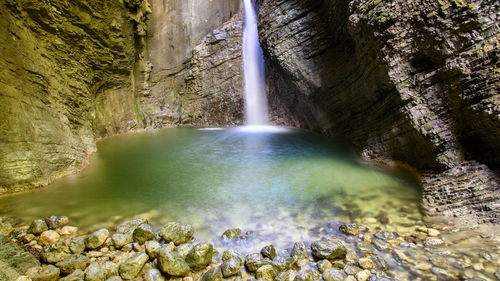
[0,0,147,193]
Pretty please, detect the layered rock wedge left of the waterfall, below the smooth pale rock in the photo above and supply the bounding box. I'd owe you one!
[140,14,243,127]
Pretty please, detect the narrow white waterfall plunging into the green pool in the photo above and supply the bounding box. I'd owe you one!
[243,0,268,126]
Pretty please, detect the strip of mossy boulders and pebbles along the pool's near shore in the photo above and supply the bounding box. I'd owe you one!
[0,216,500,281]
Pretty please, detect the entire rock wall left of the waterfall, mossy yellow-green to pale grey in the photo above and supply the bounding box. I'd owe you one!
[0,0,242,191]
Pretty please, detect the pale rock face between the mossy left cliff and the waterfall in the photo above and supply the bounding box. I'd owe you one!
[139,0,243,128]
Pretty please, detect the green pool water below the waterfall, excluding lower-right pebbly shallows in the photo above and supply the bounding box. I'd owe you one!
[0,128,420,244]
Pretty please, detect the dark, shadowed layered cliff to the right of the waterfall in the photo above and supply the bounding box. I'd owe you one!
[259,0,500,222]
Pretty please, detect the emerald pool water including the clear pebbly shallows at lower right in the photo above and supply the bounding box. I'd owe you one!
[0,127,500,280]
